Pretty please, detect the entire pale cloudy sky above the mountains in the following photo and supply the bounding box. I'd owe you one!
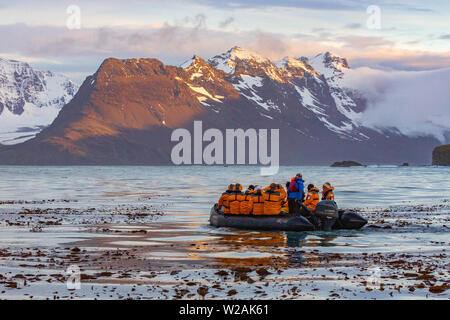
[0,0,450,83]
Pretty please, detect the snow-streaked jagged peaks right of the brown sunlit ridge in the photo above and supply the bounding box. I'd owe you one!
[208,47,367,140]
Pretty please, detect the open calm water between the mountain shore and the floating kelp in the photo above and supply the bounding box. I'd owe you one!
[0,166,450,208]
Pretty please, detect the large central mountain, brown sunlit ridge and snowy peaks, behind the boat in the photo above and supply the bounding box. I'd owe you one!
[0,47,441,165]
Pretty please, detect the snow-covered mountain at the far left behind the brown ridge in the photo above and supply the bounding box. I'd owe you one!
[0,58,78,144]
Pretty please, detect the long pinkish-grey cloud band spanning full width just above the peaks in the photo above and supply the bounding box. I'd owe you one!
[0,20,450,83]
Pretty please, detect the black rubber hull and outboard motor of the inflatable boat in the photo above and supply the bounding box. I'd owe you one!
[209,200,367,231]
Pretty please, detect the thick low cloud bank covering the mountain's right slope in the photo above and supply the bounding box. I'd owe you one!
[345,68,450,143]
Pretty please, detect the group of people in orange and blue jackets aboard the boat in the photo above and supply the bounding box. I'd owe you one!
[217,173,334,224]
